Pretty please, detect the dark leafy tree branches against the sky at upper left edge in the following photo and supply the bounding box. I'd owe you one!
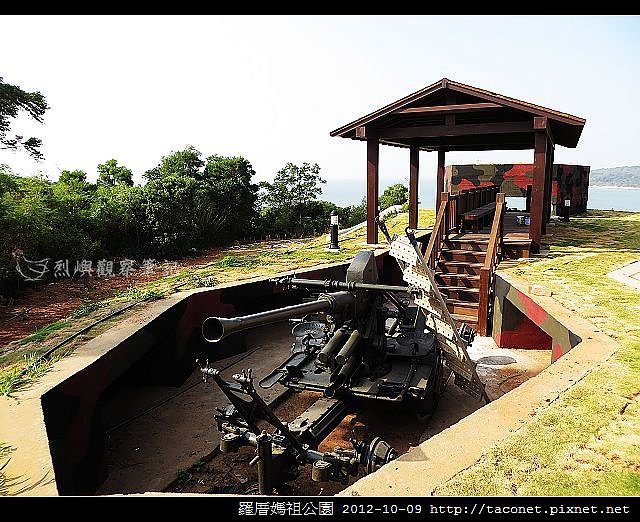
[0,77,49,159]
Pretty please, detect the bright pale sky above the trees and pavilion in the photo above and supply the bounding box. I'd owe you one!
[0,16,640,208]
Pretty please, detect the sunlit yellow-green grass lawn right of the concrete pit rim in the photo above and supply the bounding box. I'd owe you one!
[435,211,640,495]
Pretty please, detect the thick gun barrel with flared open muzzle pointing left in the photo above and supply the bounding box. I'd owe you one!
[202,292,354,343]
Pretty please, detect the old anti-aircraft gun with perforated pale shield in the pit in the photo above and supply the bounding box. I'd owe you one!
[202,225,486,494]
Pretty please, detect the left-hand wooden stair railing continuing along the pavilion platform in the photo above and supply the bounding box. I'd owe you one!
[424,185,499,270]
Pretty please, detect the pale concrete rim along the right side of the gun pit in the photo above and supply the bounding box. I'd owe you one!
[339,273,619,496]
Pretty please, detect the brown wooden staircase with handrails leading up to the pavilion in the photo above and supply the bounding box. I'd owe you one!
[425,187,505,335]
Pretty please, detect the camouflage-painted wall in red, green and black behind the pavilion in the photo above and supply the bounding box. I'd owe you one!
[444,163,590,214]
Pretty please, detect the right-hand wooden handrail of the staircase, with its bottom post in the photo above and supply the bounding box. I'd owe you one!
[478,192,506,336]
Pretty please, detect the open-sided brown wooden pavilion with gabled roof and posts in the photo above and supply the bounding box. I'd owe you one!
[331,78,585,252]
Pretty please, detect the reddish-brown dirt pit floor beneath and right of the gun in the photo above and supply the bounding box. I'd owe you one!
[167,337,551,495]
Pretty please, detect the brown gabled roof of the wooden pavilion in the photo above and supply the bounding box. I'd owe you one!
[331,78,586,150]
